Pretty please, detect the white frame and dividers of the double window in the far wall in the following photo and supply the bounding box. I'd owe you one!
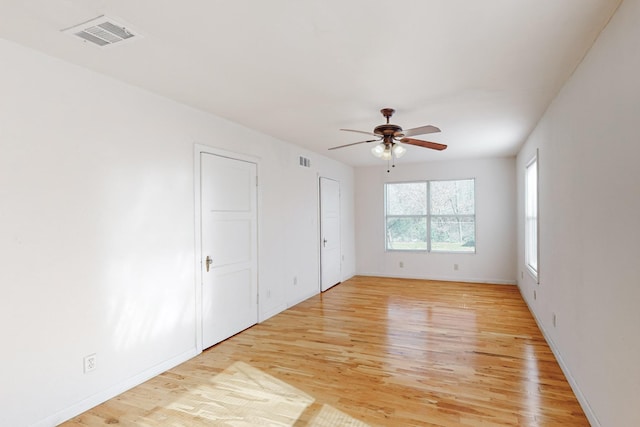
[384,178,478,254]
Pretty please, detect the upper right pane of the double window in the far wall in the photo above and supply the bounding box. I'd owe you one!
[429,179,475,215]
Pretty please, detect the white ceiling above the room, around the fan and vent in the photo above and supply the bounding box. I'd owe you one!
[0,0,621,166]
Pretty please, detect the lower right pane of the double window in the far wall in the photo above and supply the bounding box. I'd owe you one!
[431,216,476,252]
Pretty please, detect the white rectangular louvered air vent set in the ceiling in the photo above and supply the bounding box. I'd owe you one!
[62,15,140,47]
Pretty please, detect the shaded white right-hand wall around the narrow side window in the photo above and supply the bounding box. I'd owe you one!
[517,0,640,426]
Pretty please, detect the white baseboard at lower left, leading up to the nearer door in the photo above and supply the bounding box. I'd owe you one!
[33,348,199,427]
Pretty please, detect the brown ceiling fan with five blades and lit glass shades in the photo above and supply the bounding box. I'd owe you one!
[329,108,447,160]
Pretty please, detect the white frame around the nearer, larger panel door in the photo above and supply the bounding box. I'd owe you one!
[193,144,262,353]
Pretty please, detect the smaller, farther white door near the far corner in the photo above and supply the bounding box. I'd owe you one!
[320,178,342,291]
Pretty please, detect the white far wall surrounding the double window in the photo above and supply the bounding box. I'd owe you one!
[355,157,516,284]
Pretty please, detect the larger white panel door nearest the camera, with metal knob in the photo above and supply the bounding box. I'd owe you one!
[200,153,258,348]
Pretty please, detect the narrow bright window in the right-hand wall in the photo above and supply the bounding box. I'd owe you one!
[524,154,538,279]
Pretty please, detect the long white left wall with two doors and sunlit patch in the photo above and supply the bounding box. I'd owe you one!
[0,40,355,426]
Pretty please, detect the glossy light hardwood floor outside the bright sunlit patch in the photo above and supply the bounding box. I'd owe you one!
[64,277,589,427]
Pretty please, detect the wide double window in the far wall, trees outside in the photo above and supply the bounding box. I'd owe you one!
[385,179,476,253]
